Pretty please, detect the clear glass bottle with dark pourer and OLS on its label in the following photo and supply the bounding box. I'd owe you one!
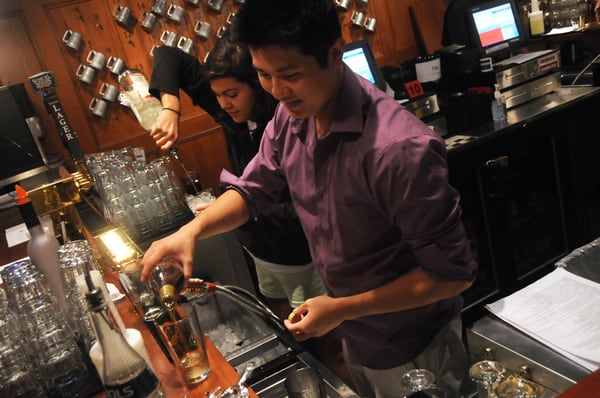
[85,278,166,398]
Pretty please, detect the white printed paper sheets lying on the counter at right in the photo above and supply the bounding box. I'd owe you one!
[486,268,600,371]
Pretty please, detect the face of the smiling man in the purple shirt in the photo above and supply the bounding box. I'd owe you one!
[250,45,337,118]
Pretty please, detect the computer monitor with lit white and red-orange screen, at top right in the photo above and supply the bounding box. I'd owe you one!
[468,0,528,60]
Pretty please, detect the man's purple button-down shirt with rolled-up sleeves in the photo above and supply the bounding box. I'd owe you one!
[222,68,477,369]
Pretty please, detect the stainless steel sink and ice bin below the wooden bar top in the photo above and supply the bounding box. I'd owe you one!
[184,290,358,398]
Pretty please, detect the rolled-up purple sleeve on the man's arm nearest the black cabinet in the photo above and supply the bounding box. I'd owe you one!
[378,134,477,281]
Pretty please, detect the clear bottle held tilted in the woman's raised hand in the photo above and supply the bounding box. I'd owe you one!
[119,69,162,131]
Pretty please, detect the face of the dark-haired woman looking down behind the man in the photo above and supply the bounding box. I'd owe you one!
[210,77,256,123]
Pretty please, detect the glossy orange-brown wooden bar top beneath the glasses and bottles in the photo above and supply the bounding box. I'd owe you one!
[0,207,257,398]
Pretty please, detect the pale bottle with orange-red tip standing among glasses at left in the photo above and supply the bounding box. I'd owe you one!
[15,184,71,319]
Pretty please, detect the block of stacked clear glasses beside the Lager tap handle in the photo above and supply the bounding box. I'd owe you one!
[86,148,193,241]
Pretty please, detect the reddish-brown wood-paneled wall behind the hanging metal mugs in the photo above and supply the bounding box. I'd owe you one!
[0,0,449,194]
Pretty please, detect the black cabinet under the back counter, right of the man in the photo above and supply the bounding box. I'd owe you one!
[448,95,600,322]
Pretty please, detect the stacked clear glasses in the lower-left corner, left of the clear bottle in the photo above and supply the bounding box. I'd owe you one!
[0,260,90,397]
